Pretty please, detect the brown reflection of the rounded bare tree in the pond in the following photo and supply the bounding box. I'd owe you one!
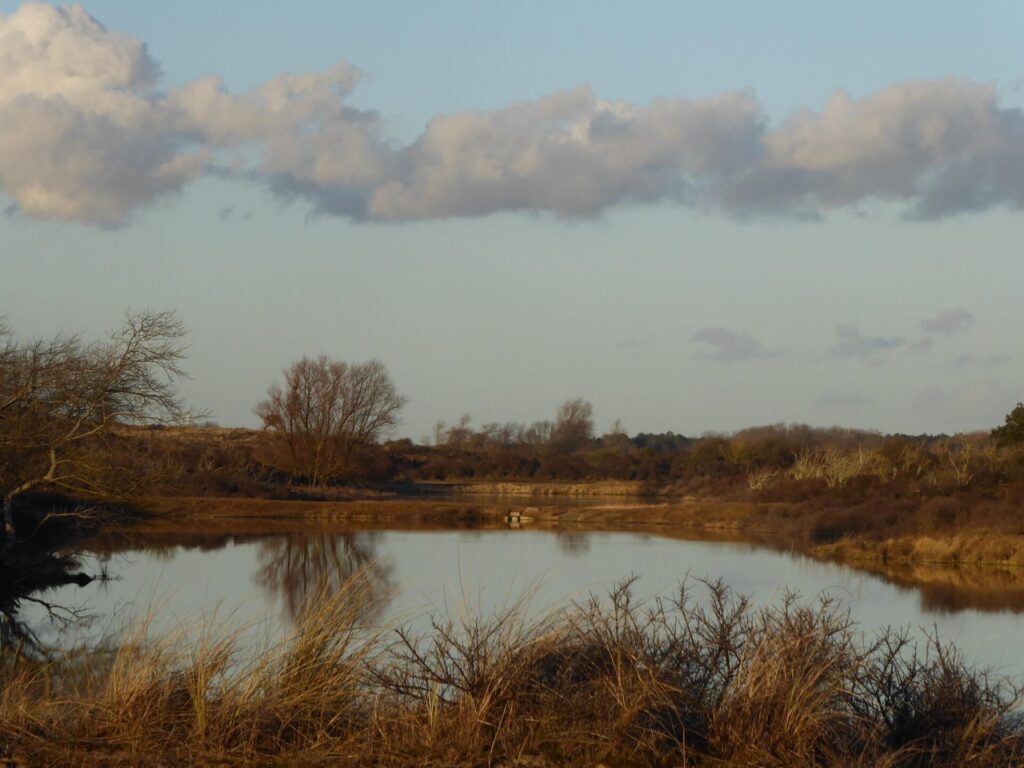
[253,531,394,622]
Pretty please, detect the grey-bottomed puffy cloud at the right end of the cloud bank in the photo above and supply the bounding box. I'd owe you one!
[731,78,1024,218]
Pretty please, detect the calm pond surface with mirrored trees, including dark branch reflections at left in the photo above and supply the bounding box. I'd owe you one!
[6,518,1024,671]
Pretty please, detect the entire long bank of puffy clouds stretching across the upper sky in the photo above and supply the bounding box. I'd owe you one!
[6,3,1024,227]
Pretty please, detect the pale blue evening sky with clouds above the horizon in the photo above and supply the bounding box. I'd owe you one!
[0,0,1024,439]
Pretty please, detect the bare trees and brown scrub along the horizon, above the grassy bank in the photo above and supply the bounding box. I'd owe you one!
[6,312,1024,518]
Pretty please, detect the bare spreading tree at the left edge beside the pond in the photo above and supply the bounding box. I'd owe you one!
[0,311,192,540]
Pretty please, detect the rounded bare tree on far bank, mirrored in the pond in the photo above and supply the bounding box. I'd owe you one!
[255,355,406,485]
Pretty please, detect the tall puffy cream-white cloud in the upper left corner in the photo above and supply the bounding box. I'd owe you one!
[0,3,204,224]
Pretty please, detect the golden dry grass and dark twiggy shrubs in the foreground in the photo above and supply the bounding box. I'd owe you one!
[0,579,1024,768]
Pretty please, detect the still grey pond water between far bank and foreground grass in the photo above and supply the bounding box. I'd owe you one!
[22,524,1024,678]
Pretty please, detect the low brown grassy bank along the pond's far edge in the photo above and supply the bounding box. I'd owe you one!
[140,490,1024,568]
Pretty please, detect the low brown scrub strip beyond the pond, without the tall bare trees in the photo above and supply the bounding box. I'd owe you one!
[108,421,1024,512]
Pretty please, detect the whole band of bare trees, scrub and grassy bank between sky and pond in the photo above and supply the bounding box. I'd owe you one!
[6,313,1024,577]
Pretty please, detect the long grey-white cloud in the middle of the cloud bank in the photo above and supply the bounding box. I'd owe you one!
[370,86,762,219]
